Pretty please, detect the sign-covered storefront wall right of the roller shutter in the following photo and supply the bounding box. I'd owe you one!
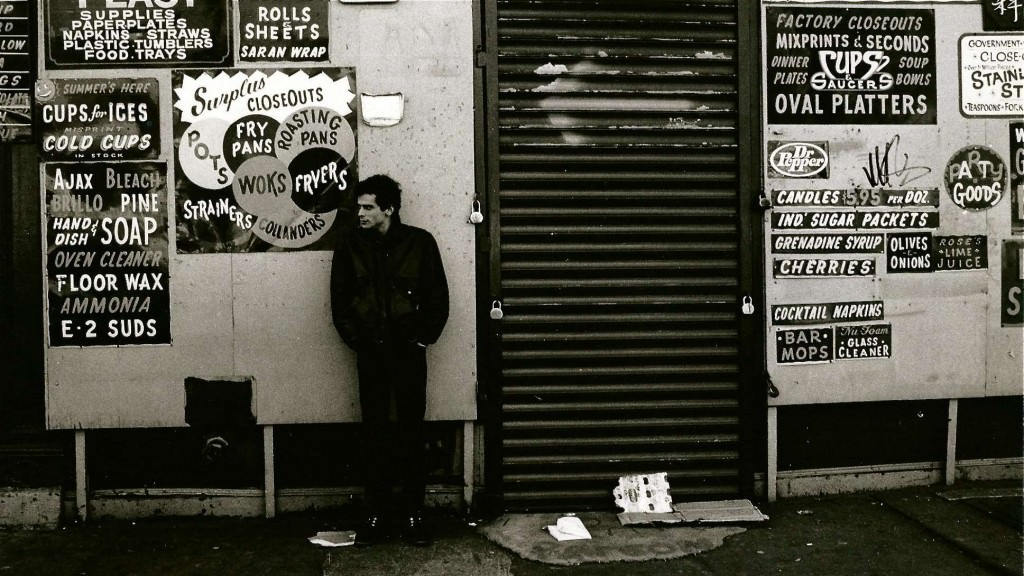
[762,2,1024,495]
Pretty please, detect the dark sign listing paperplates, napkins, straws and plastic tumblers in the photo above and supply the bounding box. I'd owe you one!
[46,0,231,69]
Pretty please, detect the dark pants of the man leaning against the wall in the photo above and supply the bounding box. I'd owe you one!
[356,342,427,515]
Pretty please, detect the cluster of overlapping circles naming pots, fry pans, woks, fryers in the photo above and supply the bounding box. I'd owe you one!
[179,107,355,248]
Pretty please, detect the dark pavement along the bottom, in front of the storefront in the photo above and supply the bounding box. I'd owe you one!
[0,483,1024,576]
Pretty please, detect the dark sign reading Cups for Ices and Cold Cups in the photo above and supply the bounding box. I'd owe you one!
[36,78,160,160]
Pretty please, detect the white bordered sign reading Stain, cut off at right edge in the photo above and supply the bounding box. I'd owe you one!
[959,34,1024,118]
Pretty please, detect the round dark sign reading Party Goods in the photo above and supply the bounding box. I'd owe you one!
[946,146,1007,210]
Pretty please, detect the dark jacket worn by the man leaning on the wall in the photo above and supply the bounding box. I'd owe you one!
[331,221,449,352]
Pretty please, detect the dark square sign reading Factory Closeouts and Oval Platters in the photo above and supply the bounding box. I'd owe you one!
[765,6,936,124]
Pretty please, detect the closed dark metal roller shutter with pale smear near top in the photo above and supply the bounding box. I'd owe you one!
[488,0,741,509]
